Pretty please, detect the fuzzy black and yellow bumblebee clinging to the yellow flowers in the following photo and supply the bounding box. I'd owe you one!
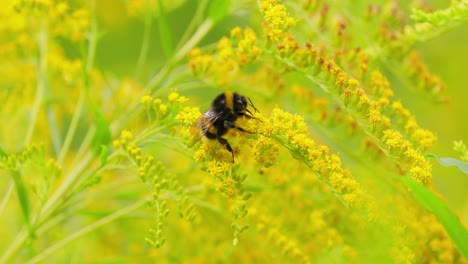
[197,92,258,163]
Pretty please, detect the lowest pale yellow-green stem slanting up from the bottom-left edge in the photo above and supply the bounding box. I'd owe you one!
[27,199,146,264]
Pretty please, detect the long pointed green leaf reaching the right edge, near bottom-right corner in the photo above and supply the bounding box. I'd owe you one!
[399,177,468,260]
